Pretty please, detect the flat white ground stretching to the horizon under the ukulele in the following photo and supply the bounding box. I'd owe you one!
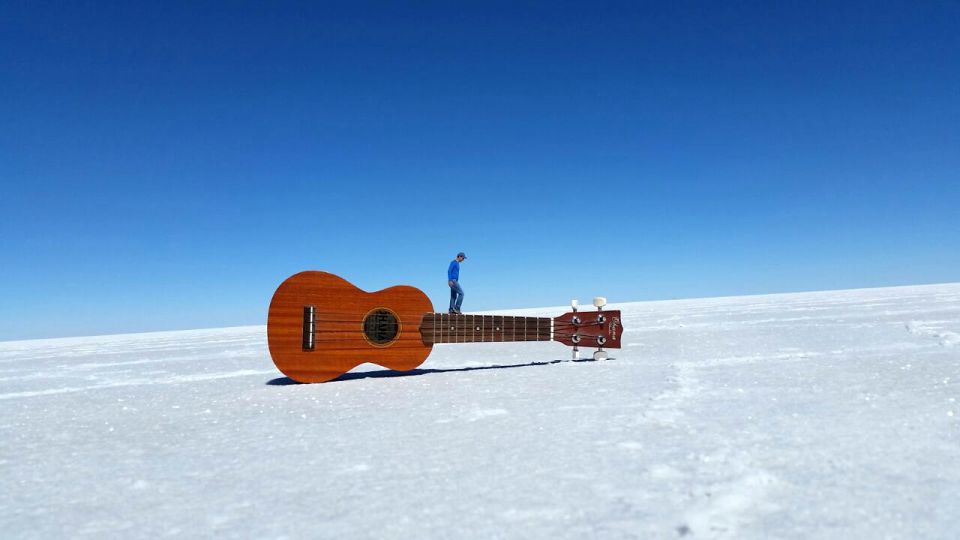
[0,284,960,539]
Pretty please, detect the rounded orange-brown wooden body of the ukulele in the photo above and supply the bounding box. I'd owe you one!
[267,271,433,382]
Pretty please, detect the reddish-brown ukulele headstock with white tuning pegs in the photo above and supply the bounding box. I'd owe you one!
[553,296,623,360]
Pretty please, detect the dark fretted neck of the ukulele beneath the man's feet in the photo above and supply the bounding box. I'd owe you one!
[420,313,552,344]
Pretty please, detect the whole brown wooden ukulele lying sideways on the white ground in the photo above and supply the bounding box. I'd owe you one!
[267,271,623,382]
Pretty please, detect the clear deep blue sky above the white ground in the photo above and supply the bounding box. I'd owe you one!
[0,0,960,340]
